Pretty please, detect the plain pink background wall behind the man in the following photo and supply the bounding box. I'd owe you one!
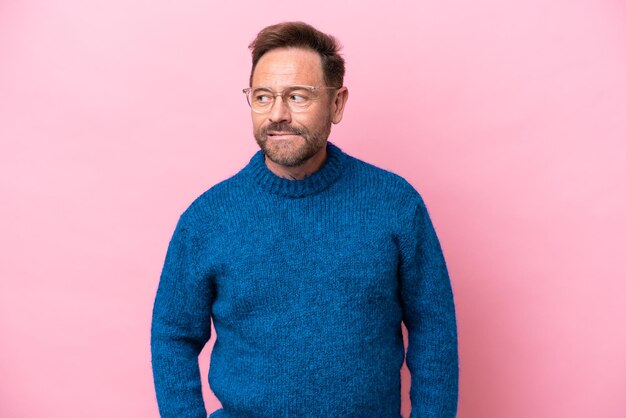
[0,0,626,418]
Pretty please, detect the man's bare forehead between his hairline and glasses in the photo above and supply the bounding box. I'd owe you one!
[253,48,324,86]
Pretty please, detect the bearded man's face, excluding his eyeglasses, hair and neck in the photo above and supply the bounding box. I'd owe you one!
[252,48,341,167]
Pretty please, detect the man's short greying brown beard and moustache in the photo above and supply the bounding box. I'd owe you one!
[254,118,331,167]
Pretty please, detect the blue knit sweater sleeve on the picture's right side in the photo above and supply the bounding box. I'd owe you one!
[399,194,459,418]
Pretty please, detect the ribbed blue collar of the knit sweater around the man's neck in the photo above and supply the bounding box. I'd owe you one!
[244,141,346,197]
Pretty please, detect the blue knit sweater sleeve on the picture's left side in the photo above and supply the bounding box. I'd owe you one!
[150,217,213,418]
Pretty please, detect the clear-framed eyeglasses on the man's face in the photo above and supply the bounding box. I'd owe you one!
[243,86,339,113]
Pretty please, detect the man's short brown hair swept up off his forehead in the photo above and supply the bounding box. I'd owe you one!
[248,22,346,87]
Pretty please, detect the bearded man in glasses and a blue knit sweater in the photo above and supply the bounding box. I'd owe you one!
[151,22,458,418]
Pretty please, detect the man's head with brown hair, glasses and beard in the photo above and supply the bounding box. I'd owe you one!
[248,22,348,171]
